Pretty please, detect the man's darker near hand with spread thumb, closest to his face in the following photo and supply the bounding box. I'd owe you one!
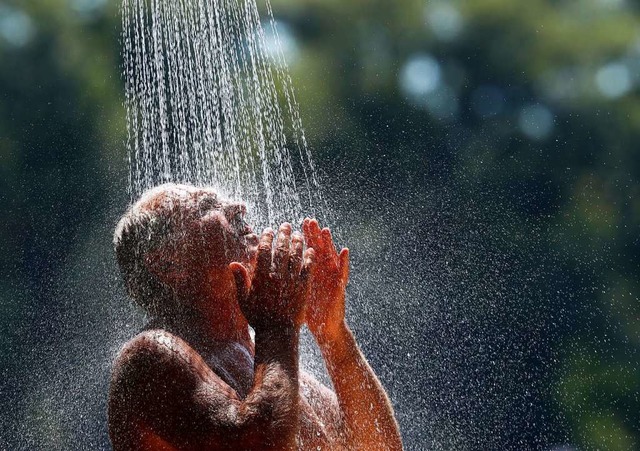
[229,223,314,331]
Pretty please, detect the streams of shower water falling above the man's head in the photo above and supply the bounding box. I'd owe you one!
[122,0,325,226]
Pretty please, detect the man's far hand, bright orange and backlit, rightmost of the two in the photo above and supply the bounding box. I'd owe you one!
[302,218,349,341]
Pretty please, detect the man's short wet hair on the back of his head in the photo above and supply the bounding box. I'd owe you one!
[113,184,179,316]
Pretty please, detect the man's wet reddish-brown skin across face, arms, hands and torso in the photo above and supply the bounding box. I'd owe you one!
[109,187,402,451]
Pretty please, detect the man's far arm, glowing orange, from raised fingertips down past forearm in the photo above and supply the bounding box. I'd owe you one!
[303,219,402,450]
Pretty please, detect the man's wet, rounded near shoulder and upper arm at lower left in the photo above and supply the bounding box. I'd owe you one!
[108,330,246,449]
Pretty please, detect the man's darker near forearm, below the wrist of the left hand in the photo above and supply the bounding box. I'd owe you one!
[239,327,300,449]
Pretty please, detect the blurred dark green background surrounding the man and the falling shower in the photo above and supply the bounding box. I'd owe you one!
[0,0,640,450]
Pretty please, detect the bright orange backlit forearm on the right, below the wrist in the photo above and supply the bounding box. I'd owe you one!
[316,322,402,450]
